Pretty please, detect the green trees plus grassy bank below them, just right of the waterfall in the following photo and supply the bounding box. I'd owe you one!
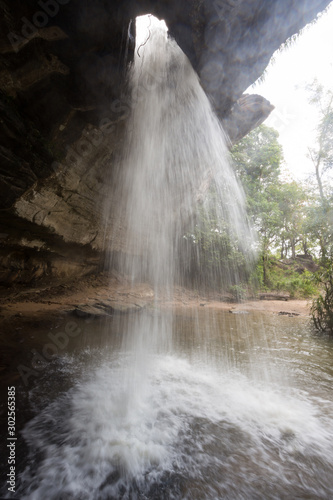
[232,125,324,297]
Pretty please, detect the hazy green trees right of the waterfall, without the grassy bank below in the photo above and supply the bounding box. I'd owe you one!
[232,125,312,261]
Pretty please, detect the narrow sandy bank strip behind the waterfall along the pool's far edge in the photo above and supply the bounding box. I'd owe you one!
[0,275,310,324]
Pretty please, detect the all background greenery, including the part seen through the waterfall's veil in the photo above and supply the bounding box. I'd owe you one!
[183,117,333,300]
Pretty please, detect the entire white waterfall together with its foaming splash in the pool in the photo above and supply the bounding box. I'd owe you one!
[11,13,333,500]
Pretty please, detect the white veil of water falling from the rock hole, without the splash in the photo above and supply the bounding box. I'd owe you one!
[116,16,253,345]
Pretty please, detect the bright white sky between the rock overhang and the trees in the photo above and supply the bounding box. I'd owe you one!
[247,2,333,180]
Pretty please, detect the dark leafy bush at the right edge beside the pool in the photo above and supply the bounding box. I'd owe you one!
[311,262,333,335]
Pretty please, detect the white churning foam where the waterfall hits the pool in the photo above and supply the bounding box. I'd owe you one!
[16,354,332,500]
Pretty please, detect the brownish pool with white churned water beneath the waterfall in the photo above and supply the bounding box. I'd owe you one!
[0,309,333,500]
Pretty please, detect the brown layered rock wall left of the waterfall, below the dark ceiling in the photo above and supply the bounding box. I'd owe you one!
[0,117,125,285]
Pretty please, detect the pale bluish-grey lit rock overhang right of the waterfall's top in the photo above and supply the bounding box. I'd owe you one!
[193,0,329,118]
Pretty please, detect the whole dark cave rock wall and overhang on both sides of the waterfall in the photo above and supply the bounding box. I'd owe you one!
[0,0,329,284]
